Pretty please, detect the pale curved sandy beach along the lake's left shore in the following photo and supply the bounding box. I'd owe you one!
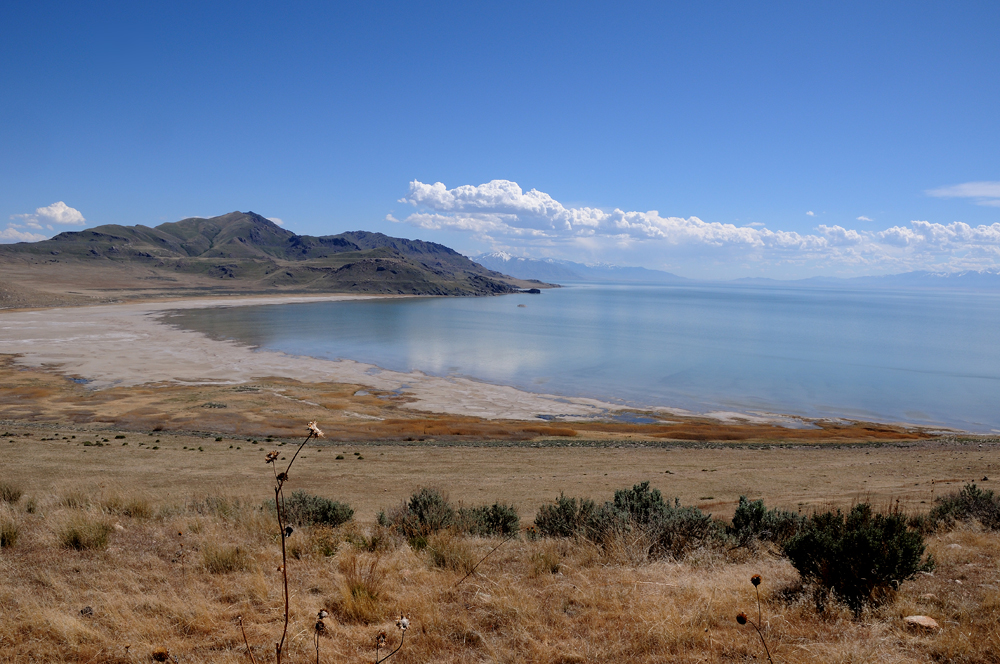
[0,295,621,420]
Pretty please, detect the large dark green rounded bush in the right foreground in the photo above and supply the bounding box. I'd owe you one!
[784,503,934,616]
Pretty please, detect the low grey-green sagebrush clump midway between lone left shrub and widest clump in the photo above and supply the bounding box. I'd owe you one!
[378,487,521,548]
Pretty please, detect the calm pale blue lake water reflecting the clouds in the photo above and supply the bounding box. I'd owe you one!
[172,284,1000,431]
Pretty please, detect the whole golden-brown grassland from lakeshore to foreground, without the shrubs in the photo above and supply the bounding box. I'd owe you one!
[0,360,1000,663]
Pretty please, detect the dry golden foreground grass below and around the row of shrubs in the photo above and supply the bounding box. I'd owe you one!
[0,486,1000,664]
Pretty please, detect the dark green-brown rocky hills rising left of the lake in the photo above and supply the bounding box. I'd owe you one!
[0,212,548,306]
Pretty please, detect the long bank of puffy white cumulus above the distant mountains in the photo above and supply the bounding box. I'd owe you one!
[387,180,1000,269]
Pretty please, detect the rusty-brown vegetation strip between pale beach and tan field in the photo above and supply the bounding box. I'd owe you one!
[0,356,933,443]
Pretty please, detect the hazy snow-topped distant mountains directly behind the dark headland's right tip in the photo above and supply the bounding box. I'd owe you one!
[472,251,690,284]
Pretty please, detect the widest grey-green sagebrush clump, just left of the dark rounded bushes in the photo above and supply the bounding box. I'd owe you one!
[535,482,723,558]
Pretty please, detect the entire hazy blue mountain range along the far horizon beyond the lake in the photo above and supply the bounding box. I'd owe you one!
[472,251,1000,290]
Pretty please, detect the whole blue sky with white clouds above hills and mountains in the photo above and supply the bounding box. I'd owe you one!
[0,2,1000,278]
